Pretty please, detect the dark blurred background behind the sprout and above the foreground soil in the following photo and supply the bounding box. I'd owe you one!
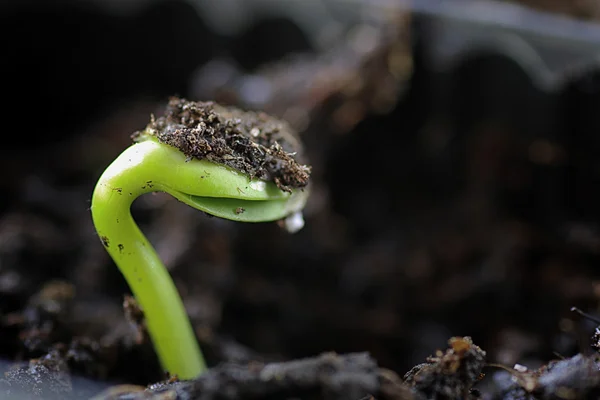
[0,0,600,396]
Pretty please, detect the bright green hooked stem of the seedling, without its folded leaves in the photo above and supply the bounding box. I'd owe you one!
[92,145,206,379]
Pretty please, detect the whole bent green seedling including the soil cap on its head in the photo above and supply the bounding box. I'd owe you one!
[91,99,310,379]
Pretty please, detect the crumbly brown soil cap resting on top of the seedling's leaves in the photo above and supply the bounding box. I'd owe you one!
[132,98,310,191]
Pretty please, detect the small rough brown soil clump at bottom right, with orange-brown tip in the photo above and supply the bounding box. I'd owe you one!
[404,337,485,399]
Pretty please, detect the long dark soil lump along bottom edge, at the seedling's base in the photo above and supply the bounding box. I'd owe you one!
[98,353,379,400]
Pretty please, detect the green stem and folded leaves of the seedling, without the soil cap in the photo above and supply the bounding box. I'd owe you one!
[91,140,307,379]
